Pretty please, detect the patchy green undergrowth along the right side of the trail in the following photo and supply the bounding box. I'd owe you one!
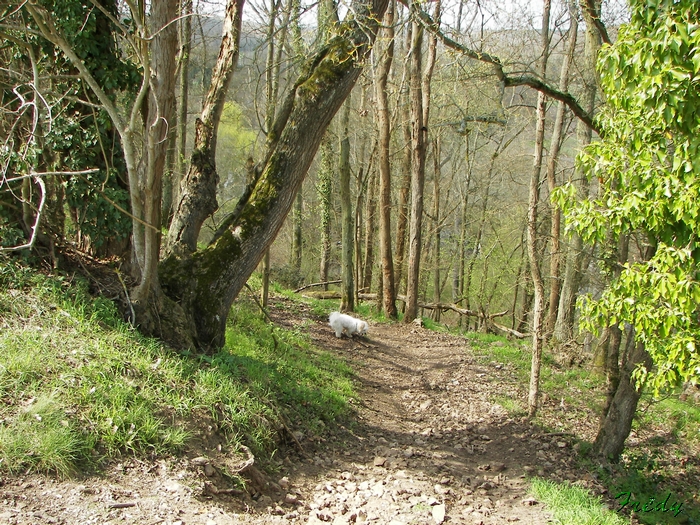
[434,333,700,525]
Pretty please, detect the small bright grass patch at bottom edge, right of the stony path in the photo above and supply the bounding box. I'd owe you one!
[531,478,629,525]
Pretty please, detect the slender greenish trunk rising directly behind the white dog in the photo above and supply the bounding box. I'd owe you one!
[338,96,355,312]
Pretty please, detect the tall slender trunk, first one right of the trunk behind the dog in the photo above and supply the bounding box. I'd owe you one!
[375,0,398,319]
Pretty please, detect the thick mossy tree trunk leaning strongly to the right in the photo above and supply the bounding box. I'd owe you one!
[160,0,388,352]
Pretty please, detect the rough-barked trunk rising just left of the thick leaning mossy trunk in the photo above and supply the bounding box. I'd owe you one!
[167,0,244,254]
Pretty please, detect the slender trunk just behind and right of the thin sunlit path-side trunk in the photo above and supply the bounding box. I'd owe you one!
[544,0,578,339]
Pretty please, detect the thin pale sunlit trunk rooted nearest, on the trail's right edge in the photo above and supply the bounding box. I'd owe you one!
[527,0,551,417]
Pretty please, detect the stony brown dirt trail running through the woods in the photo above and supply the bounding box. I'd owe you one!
[0,310,576,525]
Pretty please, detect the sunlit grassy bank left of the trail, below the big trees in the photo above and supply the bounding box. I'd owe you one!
[0,260,354,475]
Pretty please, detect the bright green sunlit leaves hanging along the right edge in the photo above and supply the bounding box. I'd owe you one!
[555,0,700,392]
